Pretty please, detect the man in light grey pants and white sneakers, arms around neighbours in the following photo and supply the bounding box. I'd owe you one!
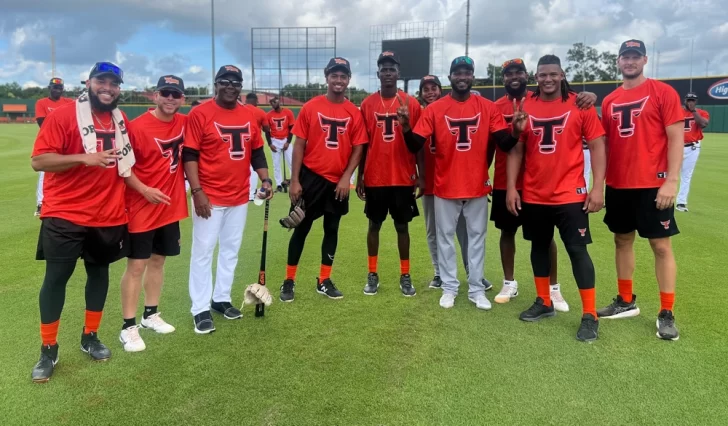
[410,56,526,310]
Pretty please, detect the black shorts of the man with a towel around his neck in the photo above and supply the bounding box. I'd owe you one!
[35,217,130,265]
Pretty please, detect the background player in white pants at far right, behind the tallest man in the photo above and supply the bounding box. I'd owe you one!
[675,93,710,212]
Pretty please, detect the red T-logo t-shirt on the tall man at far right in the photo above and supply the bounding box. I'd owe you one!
[602,78,685,188]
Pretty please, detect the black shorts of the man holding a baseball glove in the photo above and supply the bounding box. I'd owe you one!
[298,165,349,220]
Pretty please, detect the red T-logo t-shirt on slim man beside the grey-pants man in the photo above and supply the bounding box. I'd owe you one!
[361,91,422,187]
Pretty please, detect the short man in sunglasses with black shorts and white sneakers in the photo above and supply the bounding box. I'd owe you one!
[119,75,187,352]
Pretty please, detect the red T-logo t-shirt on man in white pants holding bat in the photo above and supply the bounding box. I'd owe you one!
[184,102,263,207]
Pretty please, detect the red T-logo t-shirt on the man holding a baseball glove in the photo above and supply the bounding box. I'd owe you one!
[293,95,368,183]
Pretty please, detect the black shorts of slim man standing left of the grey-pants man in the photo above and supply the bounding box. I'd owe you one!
[364,186,420,224]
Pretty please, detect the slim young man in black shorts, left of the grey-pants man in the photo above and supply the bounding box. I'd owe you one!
[356,51,422,297]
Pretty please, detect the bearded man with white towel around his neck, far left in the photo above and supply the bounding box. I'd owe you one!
[31,62,133,383]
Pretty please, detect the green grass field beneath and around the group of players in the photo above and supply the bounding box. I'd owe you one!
[0,125,728,425]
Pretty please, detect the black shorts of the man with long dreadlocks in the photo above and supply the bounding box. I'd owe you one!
[521,202,592,245]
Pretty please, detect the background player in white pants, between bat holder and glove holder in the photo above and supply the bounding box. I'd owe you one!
[265,96,296,192]
